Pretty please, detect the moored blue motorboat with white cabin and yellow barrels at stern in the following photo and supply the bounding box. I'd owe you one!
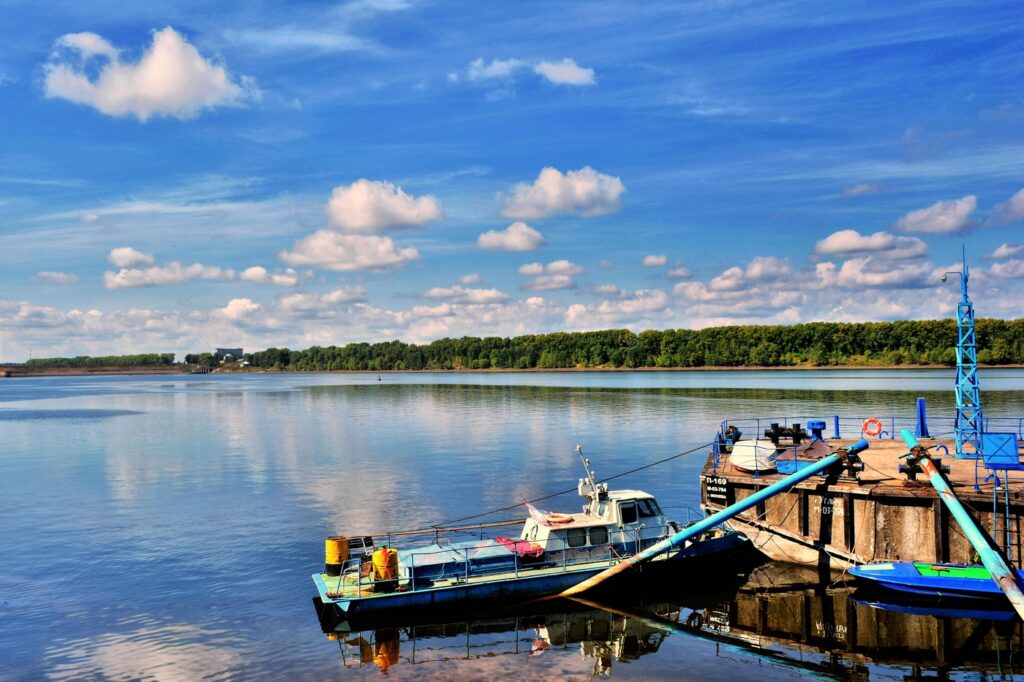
[312,459,753,617]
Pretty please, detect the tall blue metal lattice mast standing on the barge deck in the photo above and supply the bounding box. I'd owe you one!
[942,244,984,459]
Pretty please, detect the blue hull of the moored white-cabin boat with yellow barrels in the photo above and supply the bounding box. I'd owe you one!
[313,532,755,619]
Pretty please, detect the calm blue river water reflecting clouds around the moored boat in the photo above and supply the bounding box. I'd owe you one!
[0,370,1024,681]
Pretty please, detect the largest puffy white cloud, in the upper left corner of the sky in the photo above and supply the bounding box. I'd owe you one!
[43,27,259,122]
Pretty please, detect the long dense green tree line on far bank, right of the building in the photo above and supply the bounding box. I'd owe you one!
[232,319,1024,371]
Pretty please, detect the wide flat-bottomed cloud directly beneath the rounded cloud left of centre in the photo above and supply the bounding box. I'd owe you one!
[279,229,420,272]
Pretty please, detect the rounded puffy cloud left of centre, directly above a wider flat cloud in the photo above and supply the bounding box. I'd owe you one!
[326,179,442,232]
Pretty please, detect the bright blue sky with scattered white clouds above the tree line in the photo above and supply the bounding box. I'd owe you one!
[0,0,1024,361]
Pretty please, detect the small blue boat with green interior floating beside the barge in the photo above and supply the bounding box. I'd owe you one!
[848,561,1024,600]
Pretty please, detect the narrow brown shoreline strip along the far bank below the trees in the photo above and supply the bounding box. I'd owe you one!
[0,365,1024,379]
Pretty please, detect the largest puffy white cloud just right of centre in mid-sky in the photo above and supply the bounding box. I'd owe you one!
[502,166,626,220]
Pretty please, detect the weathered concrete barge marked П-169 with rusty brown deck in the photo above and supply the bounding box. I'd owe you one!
[700,420,1024,569]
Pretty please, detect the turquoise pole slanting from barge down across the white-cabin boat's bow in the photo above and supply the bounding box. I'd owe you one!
[558,440,868,597]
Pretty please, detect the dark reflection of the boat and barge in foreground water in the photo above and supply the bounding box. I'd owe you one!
[317,563,1024,680]
